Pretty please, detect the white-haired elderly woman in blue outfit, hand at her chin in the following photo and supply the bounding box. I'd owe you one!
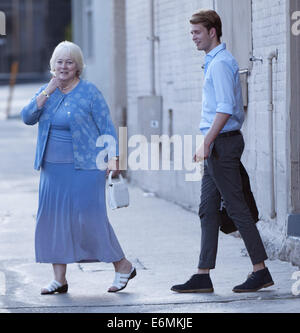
[21,41,136,295]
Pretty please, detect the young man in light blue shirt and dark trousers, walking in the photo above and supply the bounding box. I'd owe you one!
[171,10,274,293]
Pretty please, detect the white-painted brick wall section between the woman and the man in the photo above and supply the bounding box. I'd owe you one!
[126,0,212,211]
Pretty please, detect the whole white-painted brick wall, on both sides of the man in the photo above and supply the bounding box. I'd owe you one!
[126,0,290,255]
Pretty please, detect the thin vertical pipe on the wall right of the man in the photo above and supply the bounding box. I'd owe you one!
[268,50,278,219]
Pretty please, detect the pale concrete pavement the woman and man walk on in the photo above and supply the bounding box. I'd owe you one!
[0,83,300,313]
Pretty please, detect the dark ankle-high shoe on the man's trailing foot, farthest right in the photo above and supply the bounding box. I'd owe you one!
[232,267,274,293]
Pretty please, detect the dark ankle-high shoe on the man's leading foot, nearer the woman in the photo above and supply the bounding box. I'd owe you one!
[171,274,214,293]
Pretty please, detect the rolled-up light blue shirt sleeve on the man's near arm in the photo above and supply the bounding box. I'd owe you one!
[211,61,235,115]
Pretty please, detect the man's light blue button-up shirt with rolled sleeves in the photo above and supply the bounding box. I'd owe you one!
[199,43,244,136]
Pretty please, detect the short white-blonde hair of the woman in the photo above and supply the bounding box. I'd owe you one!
[50,41,85,77]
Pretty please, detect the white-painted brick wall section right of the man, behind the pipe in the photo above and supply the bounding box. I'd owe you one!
[244,0,290,241]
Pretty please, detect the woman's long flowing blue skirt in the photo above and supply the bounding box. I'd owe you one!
[35,161,124,264]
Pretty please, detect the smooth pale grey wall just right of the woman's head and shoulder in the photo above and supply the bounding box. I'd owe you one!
[73,0,127,127]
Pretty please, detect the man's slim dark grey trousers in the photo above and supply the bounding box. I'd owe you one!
[198,134,268,269]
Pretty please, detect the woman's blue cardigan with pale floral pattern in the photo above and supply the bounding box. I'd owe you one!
[21,80,119,170]
